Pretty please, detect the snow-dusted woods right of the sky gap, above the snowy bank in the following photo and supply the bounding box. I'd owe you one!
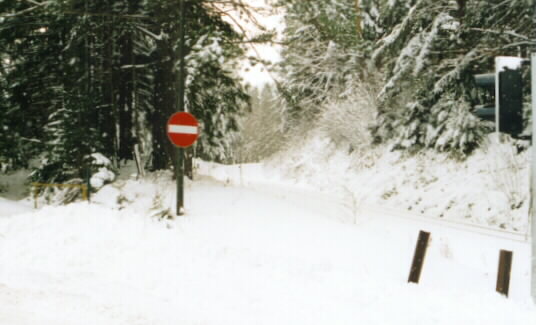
[278,0,536,156]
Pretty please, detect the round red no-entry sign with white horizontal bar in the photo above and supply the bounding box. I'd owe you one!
[167,112,199,148]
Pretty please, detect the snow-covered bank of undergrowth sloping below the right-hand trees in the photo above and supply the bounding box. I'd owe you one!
[267,132,530,233]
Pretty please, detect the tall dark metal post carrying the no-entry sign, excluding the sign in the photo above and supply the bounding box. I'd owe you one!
[175,0,186,216]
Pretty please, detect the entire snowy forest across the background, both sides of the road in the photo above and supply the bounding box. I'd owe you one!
[0,0,536,182]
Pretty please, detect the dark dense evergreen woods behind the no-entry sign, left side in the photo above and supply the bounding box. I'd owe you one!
[0,0,249,181]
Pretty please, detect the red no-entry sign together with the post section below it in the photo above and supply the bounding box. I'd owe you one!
[166,112,199,215]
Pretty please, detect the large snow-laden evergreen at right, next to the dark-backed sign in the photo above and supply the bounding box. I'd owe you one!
[370,0,534,153]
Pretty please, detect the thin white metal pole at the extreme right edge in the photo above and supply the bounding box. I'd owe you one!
[529,52,536,302]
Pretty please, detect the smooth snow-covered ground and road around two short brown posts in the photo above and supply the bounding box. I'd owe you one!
[0,178,536,325]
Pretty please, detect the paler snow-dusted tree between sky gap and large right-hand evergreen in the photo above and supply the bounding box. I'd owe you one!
[279,0,370,119]
